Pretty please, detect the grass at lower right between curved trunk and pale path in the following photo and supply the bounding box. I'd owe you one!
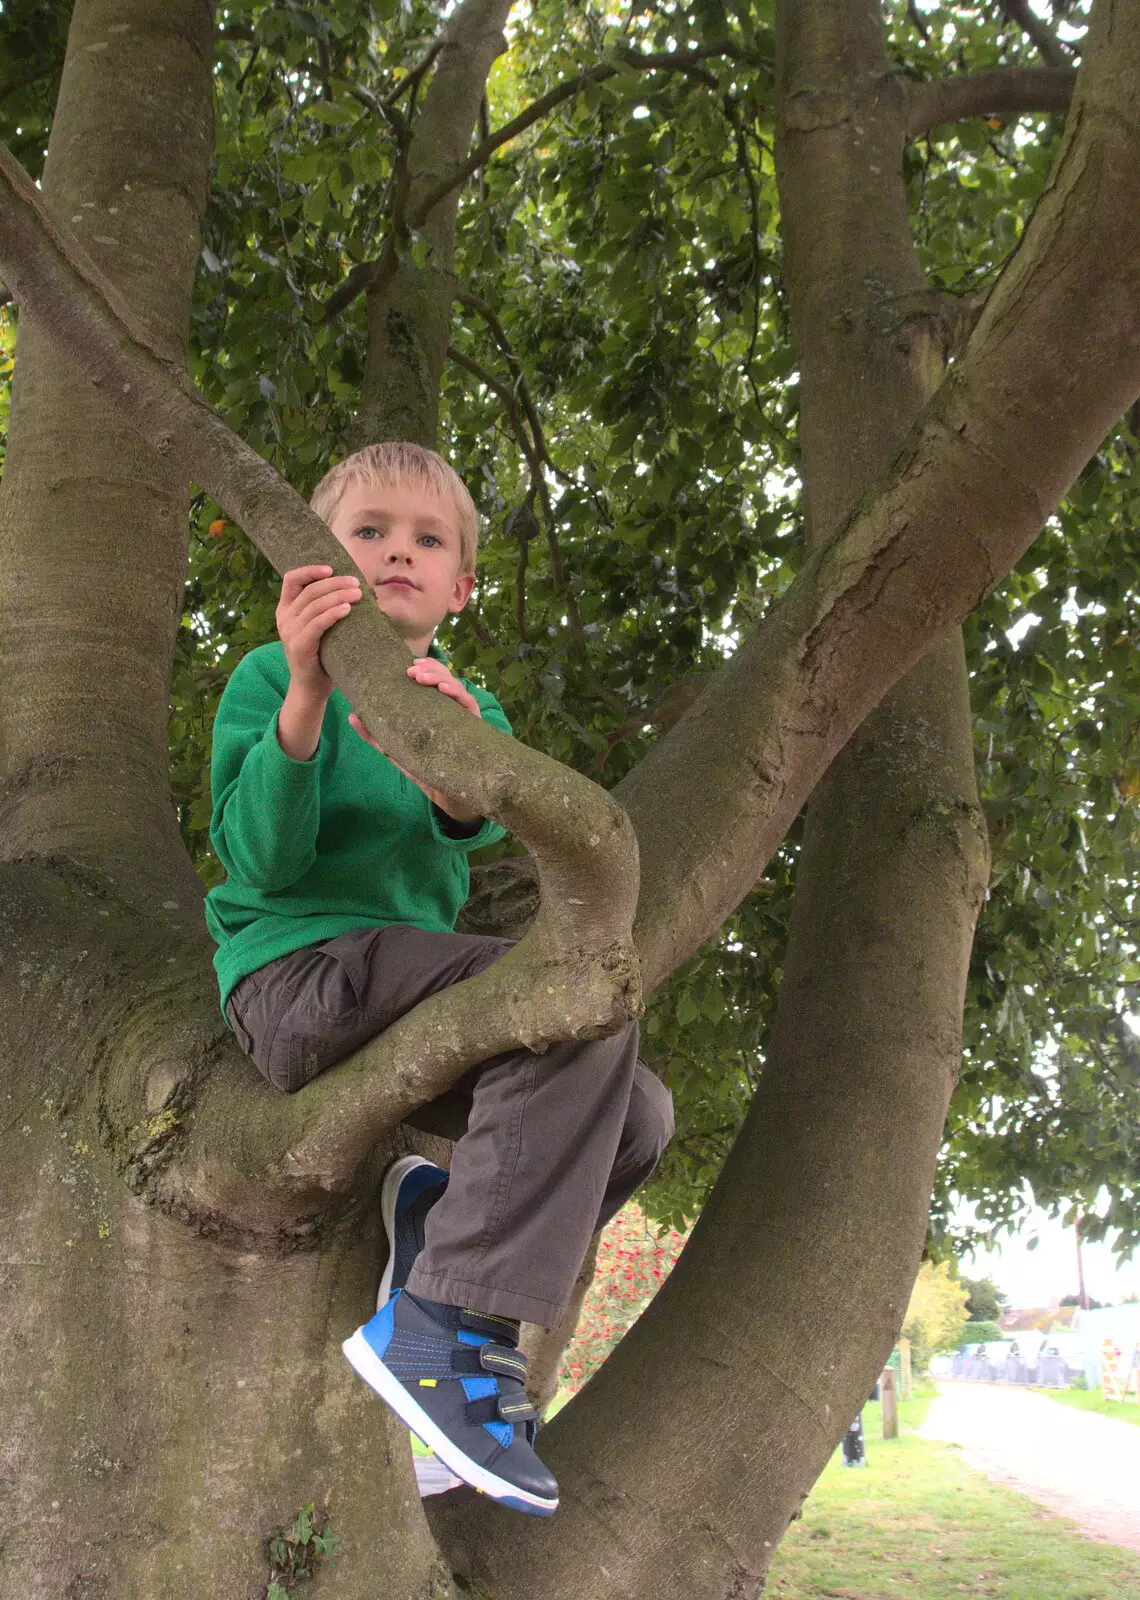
[765,1395,1140,1600]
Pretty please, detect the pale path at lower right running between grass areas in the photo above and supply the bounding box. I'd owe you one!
[919,1381,1140,1550]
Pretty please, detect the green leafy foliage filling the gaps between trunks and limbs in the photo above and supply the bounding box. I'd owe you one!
[0,0,1140,1251]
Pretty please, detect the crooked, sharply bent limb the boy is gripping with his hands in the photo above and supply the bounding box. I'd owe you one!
[0,137,639,1194]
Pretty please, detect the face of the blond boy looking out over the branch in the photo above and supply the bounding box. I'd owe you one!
[328,483,476,656]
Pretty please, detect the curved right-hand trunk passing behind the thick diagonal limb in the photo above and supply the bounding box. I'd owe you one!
[436,0,988,1600]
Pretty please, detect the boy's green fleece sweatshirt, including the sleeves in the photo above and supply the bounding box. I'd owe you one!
[207,645,511,1014]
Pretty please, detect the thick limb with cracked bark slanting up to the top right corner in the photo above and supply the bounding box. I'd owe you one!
[615,0,1140,989]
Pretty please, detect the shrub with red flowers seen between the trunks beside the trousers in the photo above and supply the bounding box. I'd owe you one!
[559,1200,685,1394]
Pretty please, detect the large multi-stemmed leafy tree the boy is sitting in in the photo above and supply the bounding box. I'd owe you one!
[0,0,1140,1600]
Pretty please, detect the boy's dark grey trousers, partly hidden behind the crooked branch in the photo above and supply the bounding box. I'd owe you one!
[226,926,672,1328]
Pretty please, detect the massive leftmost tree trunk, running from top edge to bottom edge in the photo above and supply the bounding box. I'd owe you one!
[0,0,452,1600]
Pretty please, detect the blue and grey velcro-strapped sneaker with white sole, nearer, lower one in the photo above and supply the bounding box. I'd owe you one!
[343,1290,559,1517]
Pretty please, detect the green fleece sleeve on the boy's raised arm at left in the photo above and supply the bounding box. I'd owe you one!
[210,651,320,890]
